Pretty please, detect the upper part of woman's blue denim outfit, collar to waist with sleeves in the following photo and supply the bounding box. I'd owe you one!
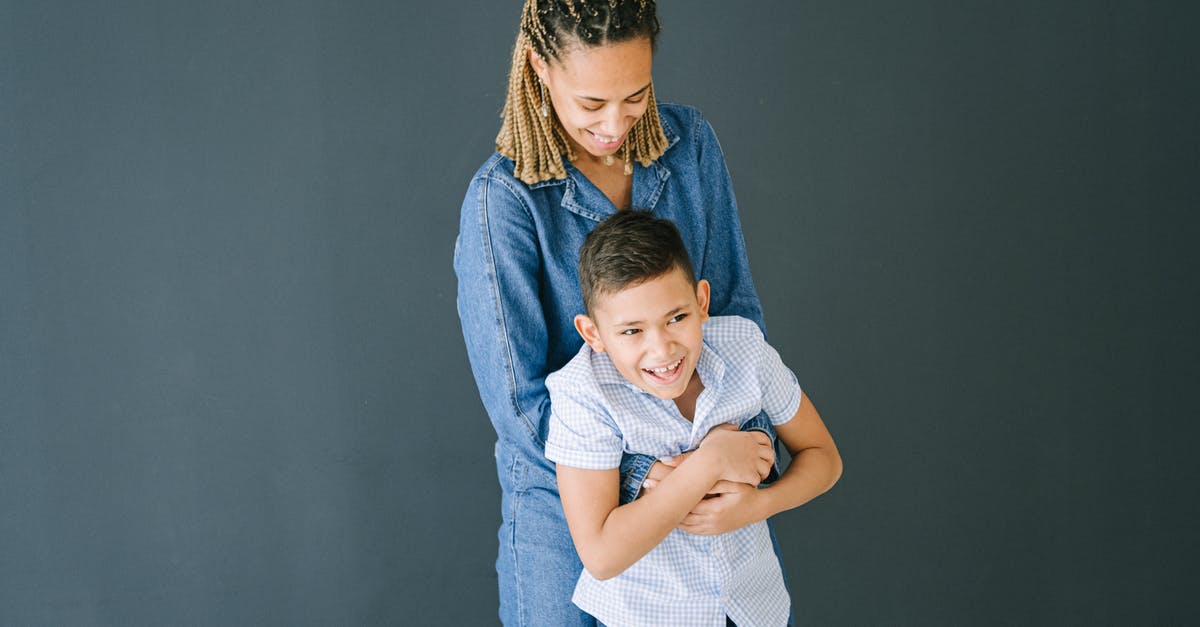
[454,105,774,500]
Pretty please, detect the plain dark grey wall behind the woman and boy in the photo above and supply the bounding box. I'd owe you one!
[0,0,1200,625]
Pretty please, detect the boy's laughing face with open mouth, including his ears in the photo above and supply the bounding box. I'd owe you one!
[575,268,709,400]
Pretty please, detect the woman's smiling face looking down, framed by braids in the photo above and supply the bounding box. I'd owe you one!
[529,38,654,159]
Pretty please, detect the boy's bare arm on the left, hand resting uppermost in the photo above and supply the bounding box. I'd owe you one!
[558,426,770,579]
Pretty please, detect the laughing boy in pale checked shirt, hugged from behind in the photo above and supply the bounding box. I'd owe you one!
[546,211,841,627]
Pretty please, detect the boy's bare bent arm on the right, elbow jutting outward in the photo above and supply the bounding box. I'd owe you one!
[679,393,842,536]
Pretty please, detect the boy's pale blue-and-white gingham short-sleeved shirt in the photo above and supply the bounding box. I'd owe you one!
[546,316,800,627]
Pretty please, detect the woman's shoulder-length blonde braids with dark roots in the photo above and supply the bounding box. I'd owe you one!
[496,0,667,184]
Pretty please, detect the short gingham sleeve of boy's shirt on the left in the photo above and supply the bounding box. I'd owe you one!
[546,363,623,470]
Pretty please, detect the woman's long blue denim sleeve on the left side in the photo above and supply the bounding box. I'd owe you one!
[454,163,550,446]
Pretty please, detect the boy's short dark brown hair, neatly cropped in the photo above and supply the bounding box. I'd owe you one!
[578,210,696,316]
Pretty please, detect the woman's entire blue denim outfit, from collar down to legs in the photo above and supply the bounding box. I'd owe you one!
[455,105,769,627]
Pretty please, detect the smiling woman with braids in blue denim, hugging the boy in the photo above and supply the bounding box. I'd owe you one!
[455,0,782,627]
